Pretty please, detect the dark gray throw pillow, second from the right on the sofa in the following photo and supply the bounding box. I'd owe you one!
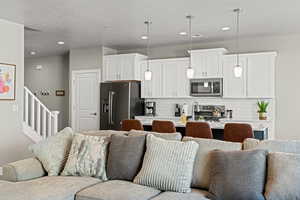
[209,150,267,200]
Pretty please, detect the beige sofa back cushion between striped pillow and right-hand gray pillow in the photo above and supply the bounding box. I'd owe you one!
[183,137,242,190]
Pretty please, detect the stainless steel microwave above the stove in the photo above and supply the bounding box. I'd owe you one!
[190,78,223,97]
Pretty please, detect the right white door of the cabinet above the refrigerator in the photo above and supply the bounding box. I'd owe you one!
[120,54,135,80]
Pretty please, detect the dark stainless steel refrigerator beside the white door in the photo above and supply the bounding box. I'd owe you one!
[100,81,144,130]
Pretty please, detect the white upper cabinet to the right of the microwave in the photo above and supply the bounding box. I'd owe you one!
[223,52,276,98]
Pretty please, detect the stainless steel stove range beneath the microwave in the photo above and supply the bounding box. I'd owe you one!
[193,103,225,121]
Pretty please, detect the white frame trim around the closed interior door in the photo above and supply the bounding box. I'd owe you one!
[70,69,101,130]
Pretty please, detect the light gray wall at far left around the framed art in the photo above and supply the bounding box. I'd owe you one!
[0,19,31,165]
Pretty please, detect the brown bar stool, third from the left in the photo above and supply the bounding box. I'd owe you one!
[185,122,213,139]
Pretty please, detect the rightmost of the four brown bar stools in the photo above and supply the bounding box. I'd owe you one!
[224,123,254,142]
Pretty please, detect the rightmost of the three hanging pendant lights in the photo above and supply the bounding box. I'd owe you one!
[233,8,243,78]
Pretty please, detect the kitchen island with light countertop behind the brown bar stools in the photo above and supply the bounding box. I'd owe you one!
[135,116,270,140]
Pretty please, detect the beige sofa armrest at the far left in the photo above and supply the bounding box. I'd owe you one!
[0,158,46,182]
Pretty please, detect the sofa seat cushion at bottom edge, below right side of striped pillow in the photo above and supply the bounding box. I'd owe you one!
[152,189,209,200]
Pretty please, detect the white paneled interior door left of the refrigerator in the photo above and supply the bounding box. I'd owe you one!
[72,70,100,131]
